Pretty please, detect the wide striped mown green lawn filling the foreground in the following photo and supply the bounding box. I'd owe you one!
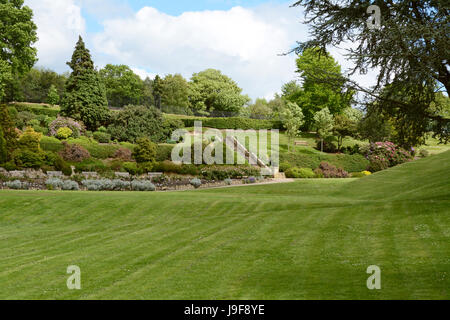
[0,152,450,299]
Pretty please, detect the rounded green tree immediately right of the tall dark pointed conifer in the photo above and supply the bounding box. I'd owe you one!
[99,64,144,108]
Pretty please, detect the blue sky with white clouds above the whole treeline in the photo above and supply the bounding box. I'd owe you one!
[25,0,375,99]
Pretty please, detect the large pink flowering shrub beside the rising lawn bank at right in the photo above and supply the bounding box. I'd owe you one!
[361,142,413,172]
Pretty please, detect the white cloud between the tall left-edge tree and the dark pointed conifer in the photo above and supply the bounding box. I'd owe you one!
[25,0,85,72]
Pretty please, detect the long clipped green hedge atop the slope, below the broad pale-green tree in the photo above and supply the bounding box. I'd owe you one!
[164,114,283,130]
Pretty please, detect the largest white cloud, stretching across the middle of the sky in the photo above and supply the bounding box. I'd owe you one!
[93,5,306,98]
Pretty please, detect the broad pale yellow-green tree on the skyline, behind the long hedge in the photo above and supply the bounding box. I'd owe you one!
[189,69,250,116]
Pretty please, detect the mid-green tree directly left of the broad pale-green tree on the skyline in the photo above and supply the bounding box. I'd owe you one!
[161,74,189,112]
